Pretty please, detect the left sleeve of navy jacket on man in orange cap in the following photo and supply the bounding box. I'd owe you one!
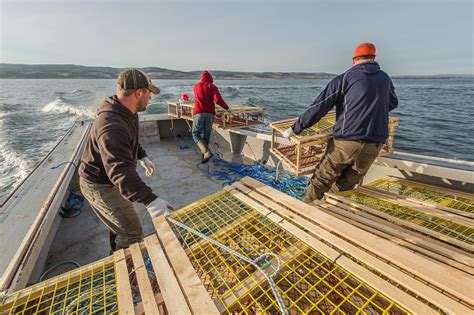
[292,75,343,134]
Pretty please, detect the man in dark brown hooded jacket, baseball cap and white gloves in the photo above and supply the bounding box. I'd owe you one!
[79,68,173,251]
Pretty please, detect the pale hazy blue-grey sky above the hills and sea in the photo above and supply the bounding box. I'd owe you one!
[0,0,474,75]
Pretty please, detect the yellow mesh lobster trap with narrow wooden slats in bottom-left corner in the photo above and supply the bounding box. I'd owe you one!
[0,247,163,314]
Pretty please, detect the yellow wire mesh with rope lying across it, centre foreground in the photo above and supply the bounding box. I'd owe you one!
[168,190,407,314]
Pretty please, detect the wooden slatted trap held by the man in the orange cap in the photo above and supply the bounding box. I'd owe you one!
[270,111,399,175]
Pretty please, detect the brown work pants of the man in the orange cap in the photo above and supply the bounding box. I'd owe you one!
[303,139,382,202]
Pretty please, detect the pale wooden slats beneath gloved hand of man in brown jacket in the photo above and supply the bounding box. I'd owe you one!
[114,227,218,314]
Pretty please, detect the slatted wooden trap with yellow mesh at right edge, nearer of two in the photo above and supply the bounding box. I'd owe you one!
[318,186,474,276]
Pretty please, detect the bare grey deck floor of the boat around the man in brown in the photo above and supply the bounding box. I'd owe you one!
[45,138,252,278]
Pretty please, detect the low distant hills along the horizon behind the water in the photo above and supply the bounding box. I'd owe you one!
[0,63,335,80]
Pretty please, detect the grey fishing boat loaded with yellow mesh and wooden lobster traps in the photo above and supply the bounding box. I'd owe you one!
[0,114,474,314]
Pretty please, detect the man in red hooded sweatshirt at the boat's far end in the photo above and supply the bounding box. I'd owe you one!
[192,71,229,163]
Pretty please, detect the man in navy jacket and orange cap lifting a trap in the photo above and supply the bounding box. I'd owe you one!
[283,43,398,202]
